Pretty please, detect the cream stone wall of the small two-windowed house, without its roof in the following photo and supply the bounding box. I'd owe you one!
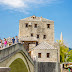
[31,49,58,62]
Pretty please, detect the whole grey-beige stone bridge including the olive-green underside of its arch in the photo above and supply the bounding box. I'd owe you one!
[0,43,34,72]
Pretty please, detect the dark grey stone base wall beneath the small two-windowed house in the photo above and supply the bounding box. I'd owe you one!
[38,62,60,72]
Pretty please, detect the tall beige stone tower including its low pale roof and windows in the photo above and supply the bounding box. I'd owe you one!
[19,16,54,45]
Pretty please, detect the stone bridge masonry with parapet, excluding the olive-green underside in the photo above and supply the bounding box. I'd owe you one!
[0,43,34,72]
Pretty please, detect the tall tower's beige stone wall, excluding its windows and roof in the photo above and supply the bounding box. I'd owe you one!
[19,17,54,44]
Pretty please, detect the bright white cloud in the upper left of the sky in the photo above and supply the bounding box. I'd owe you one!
[0,0,56,11]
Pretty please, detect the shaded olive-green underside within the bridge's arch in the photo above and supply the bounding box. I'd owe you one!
[9,58,28,72]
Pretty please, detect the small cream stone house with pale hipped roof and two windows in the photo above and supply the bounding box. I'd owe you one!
[31,42,58,62]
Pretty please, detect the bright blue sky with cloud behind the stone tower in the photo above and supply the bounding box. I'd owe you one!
[0,0,72,48]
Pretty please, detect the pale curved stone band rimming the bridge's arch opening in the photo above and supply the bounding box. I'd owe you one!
[6,52,30,72]
